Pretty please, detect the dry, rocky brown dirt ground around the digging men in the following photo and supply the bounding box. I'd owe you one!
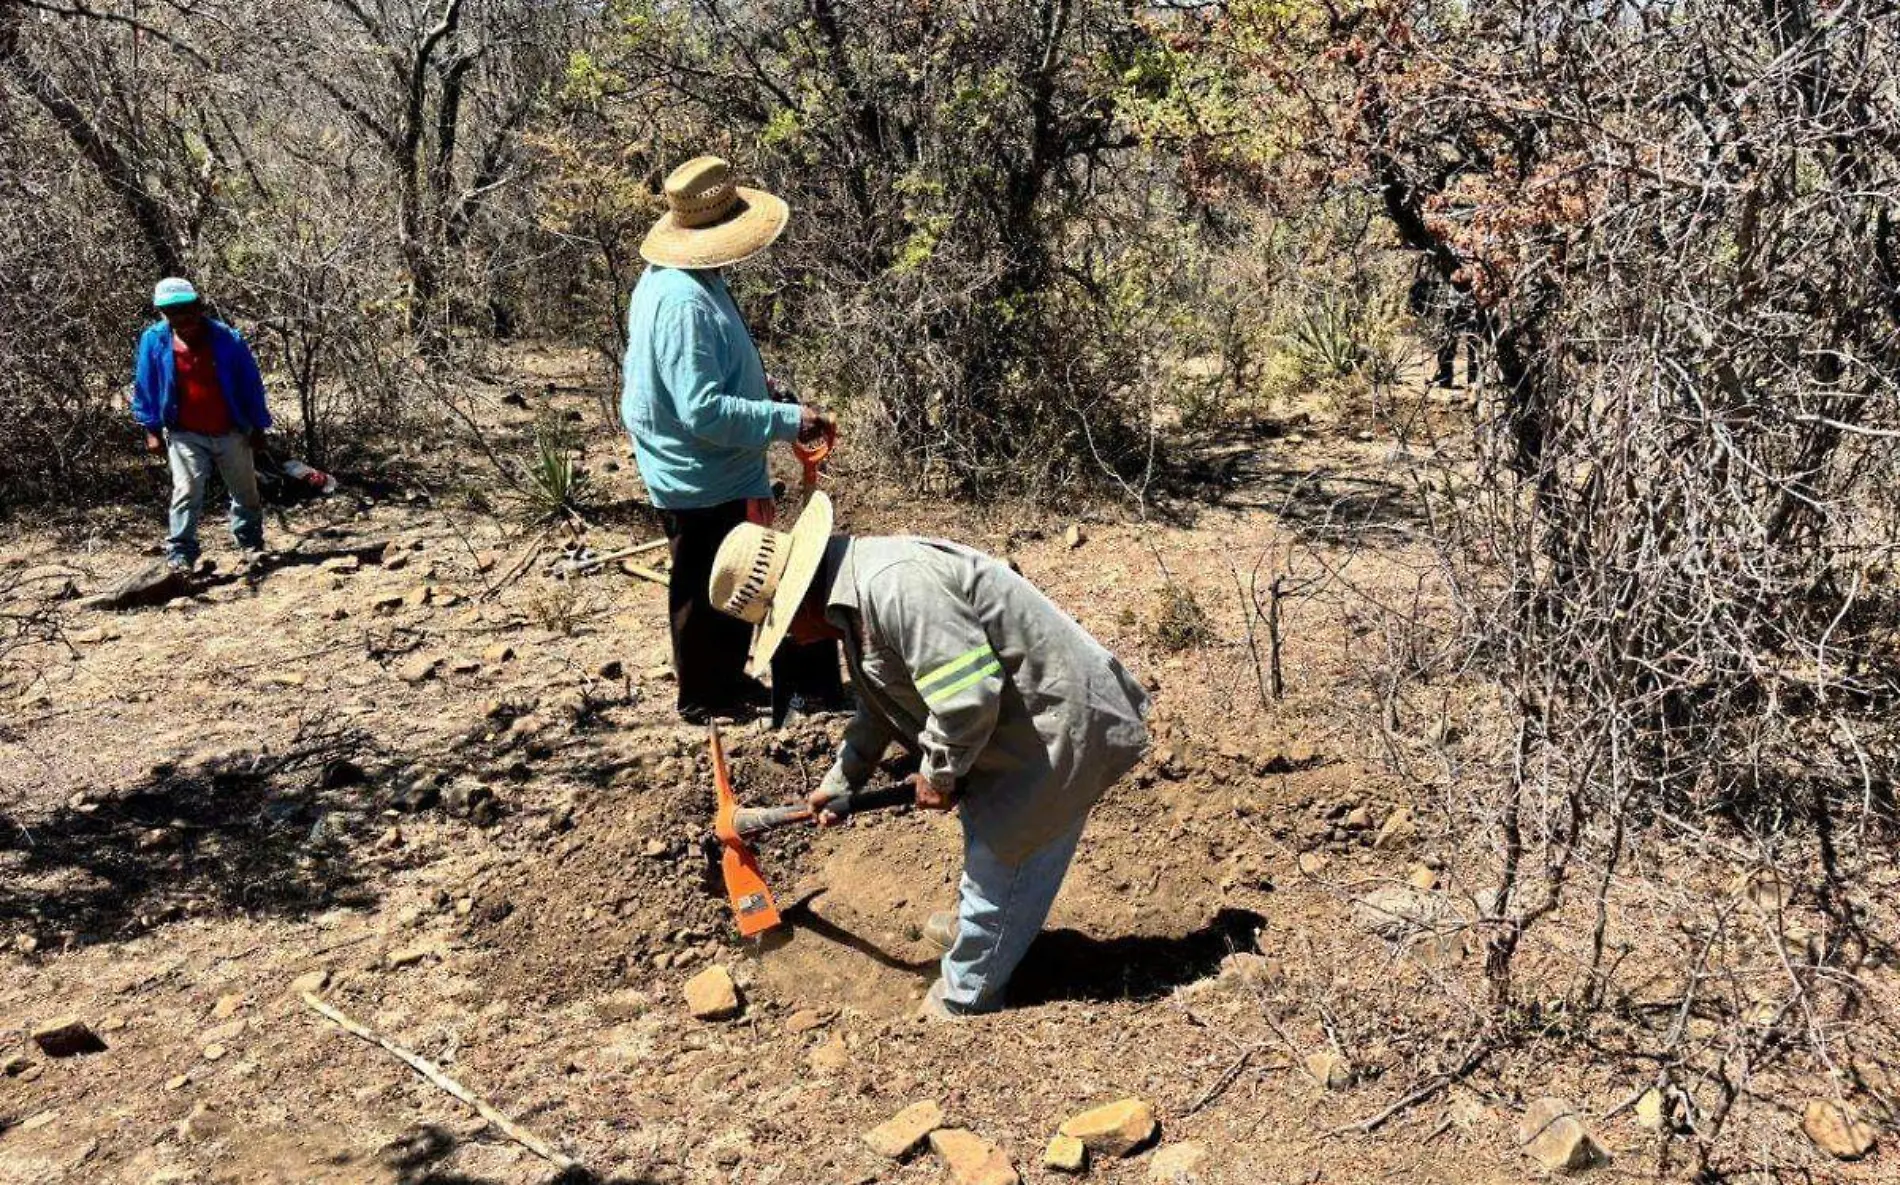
[0,347,1894,1185]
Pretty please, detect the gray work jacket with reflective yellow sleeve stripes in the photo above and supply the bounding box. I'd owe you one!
[819,536,1148,864]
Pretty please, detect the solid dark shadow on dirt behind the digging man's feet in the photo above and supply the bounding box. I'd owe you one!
[1009,910,1265,1005]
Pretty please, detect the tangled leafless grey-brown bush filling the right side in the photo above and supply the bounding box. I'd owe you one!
[1207,0,1900,1172]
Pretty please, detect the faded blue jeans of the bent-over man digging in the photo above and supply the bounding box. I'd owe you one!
[937,818,1089,1012]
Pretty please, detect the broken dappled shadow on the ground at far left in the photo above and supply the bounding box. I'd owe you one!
[0,717,380,946]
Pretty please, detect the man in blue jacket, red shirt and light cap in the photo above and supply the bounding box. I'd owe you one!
[131,277,270,572]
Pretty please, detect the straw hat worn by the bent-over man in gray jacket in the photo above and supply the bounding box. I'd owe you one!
[707,490,832,676]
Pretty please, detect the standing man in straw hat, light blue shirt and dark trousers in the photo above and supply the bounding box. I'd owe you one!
[619,156,838,724]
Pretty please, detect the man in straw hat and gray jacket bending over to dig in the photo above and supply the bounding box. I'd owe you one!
[709,494,1148,1020]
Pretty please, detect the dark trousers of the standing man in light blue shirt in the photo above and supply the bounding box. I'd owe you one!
[663,498,842,718]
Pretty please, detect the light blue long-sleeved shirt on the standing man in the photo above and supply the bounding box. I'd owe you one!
[619,266,800,511]
